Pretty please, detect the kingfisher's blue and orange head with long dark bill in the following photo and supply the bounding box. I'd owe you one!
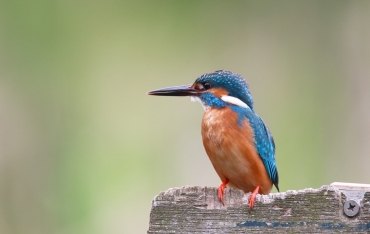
[148,70,253,110]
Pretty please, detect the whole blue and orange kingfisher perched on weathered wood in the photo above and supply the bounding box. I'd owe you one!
[148,70,279,210]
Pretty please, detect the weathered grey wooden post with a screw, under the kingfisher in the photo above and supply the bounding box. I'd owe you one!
[148,183,370,233]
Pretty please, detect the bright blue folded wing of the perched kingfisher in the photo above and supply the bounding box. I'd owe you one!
[232,107,279,191]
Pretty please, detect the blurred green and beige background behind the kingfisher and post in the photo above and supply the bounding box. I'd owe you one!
[0,0,370,234]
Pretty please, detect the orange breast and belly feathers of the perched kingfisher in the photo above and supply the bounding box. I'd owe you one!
[202,107,272,194]
